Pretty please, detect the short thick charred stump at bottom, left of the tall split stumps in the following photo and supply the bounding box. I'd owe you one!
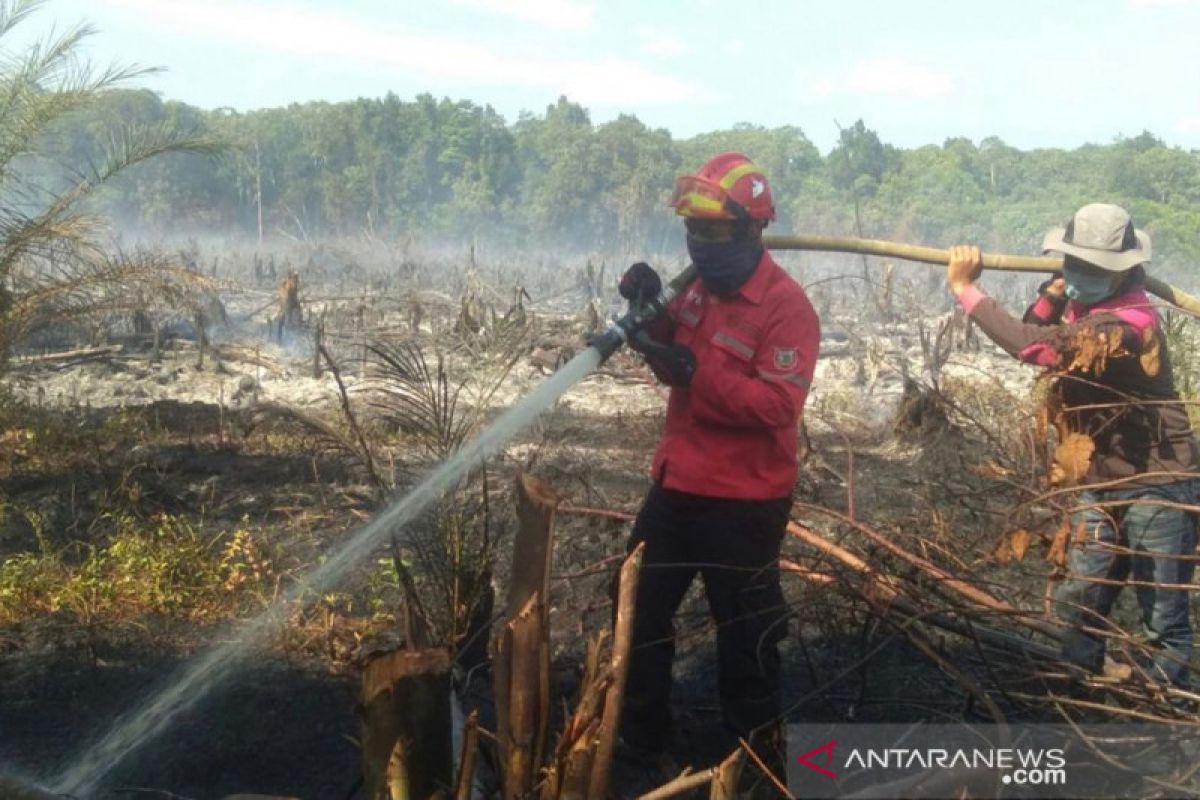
[358,649,454,800]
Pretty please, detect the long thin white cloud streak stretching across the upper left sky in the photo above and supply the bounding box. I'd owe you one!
[115,0,696,106]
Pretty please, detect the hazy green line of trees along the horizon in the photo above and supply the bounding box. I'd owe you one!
[51,90,1200,275]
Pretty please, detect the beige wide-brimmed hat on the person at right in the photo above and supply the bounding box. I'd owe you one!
[1042,203,1150,272]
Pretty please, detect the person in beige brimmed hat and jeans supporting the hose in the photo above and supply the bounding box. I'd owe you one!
[947,203,1198,687]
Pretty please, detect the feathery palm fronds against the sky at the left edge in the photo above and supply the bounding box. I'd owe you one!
[0,0,221,365]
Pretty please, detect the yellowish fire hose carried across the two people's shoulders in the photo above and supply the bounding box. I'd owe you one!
[762,236,1200,315]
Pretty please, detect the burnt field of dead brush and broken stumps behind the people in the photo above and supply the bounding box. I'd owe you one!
[0,241,1200,798]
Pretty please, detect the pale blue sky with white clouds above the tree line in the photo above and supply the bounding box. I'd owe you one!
[16,0,1200,151]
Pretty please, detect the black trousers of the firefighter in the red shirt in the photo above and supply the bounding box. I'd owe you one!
[620,485,792,750]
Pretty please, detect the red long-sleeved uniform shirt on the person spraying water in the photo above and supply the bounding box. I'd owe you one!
[652,252,821,500]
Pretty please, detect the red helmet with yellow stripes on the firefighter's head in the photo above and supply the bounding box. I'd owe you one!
[671,152,775,222]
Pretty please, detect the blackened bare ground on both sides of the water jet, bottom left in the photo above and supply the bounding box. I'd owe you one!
[0,637,358,799]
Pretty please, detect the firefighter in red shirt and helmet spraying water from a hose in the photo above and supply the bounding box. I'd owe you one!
[620,152,820,786]
